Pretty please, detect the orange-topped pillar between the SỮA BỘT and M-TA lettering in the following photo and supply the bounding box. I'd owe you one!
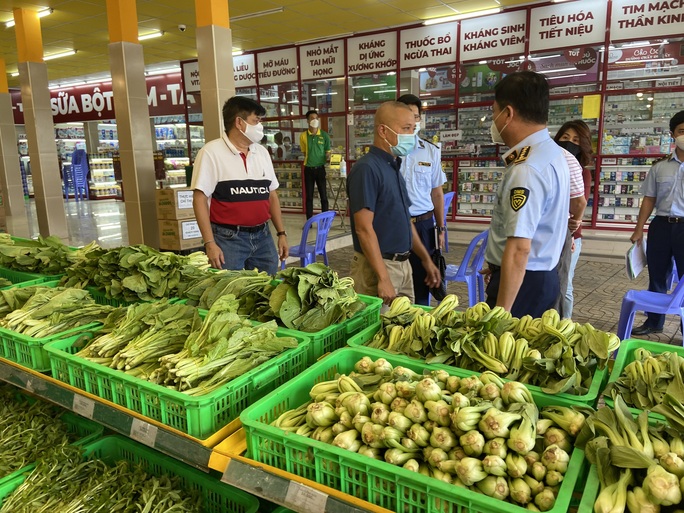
[107,0,159,248]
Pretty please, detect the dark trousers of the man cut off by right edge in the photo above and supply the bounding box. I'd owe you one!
[646,216,684,329]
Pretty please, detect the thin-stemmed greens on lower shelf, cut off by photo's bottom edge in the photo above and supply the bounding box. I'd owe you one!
[0,446,202,513]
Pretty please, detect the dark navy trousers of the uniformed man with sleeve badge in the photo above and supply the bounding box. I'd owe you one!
[487,269,560,318]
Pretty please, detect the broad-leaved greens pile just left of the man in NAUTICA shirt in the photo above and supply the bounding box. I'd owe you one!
[61,244,209,302]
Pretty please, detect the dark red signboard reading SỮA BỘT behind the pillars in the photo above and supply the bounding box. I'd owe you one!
[10,73,185,125]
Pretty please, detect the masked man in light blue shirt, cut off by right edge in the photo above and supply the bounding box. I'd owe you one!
[631,110,684,335]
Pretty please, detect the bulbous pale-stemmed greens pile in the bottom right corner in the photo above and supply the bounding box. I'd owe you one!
[576,395,684,513]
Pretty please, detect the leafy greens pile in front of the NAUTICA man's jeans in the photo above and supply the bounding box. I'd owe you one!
[179,264,366,333]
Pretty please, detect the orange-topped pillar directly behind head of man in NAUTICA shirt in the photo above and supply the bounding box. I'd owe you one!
[195,0,235,141]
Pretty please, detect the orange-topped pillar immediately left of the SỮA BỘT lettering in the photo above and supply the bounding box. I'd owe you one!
[14,9,69,238]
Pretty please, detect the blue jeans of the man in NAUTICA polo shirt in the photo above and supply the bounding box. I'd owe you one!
[211,223,278,276]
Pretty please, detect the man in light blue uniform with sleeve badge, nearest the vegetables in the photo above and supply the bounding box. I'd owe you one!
[485,71,570,317]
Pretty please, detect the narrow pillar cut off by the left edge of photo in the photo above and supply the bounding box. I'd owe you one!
[0,58,26,216]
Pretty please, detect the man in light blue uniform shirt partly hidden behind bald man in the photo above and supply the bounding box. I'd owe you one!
[397,94,446,306]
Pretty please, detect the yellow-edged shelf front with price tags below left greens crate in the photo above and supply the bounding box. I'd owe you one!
[0,358,230,471]
